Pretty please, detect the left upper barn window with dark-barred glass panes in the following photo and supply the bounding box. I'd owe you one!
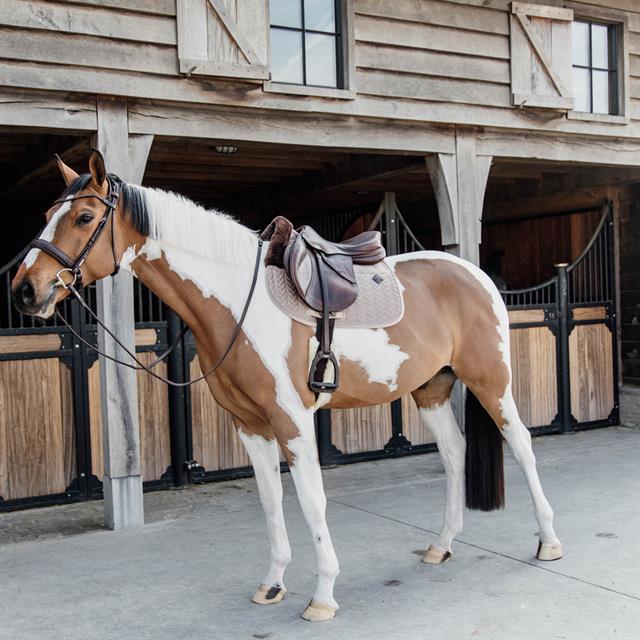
[269,0,344,89]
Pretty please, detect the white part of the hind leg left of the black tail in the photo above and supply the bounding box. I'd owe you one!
[420,399,466,553]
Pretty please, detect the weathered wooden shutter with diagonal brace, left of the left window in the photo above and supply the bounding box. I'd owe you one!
[176,0,269,80]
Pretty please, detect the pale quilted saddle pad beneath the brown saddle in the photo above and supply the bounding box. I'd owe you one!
[266,261,404,329]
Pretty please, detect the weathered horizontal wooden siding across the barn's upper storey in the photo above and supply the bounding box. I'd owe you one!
[0,0,640,142]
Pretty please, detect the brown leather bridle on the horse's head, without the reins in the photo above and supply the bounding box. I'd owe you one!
[29,176,120,289]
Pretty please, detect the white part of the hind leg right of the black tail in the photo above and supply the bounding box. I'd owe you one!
[501,385,560,544]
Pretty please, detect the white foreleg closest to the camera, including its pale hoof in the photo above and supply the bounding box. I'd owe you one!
[276,413,339,622]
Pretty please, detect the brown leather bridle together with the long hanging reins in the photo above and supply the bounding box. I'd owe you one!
[29,176,263,387]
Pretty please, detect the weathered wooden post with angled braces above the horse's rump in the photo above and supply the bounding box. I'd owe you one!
[426,131,492,264]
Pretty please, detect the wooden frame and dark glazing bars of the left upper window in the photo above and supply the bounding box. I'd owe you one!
[263,0,356,100]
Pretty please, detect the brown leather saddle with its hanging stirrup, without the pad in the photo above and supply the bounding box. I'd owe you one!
[261,216,386,393]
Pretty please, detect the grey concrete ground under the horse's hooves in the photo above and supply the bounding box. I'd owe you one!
[0,428,640,640]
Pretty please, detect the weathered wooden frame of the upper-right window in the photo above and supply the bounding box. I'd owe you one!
[566,3,630,125]
